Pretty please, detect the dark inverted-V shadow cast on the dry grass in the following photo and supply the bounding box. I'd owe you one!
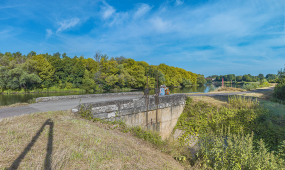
[9,119,54,170]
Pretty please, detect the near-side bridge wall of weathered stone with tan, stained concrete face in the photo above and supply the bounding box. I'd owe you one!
[74,94,186,139]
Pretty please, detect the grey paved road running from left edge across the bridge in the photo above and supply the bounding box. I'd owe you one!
[0,95,142,119]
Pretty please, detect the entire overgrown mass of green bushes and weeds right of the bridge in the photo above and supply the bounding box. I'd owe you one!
[175,96,285,169]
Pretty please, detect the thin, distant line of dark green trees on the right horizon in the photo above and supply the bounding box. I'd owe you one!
[209,74,278,83]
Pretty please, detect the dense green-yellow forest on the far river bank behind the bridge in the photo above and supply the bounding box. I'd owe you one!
[0,51,201,91]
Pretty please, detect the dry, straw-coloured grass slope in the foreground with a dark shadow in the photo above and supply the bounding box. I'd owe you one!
[0,111,183,169]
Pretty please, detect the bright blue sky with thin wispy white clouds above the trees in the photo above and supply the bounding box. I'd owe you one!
[0,0,285,76]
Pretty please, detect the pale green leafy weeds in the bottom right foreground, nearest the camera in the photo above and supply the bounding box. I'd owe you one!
[197,129,285,170]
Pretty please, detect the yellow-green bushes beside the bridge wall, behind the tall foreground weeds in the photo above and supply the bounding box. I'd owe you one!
[175,96,285,151]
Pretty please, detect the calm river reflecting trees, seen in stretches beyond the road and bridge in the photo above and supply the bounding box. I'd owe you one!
[0,84,241,106]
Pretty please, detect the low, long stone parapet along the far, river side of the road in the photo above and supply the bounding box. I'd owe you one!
[36,92,143,102]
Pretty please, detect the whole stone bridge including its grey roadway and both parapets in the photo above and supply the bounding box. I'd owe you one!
[0,92,186,139]
